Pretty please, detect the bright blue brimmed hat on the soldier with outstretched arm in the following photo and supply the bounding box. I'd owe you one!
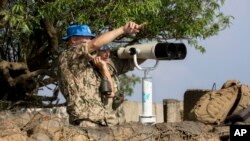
[62,25,95,41]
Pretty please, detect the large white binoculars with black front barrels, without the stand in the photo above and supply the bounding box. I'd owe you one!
[117,42,187,60]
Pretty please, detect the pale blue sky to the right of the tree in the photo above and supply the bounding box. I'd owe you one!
[126,0,250,103]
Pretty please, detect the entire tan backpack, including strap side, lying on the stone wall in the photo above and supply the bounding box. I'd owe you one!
[189,80,250,124]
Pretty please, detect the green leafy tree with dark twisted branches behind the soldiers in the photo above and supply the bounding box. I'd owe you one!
[0,0,233,106]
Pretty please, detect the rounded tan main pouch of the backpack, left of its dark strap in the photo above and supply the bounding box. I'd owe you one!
[190,86,238,124]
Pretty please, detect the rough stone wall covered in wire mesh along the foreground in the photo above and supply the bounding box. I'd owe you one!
[0,108,225,141]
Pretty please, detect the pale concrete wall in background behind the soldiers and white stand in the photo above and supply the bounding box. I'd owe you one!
[9,96,190,123]
